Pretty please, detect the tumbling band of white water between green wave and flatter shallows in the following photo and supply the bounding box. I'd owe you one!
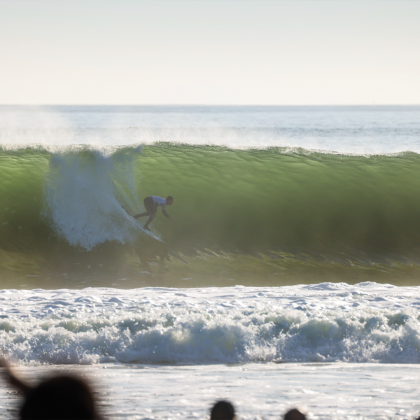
[0,283,420,364]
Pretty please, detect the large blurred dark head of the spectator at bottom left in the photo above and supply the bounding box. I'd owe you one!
[20,375,98,420]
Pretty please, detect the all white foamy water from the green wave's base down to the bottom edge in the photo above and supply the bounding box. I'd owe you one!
[0,283,420,419]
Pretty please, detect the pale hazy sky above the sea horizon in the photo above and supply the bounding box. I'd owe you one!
[0,0,420,105]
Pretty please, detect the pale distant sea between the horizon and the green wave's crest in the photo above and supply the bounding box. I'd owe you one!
[0,106,420,155]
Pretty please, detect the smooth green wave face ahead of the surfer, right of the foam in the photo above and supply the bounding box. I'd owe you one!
[147,146,420,254]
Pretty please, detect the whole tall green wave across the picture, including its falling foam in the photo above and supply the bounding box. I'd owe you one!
[0,143,420,287]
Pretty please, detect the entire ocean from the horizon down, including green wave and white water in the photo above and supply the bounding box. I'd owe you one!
[0,106,420,419]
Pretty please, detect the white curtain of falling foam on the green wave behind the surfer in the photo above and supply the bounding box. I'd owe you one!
[44,147,156,250]
